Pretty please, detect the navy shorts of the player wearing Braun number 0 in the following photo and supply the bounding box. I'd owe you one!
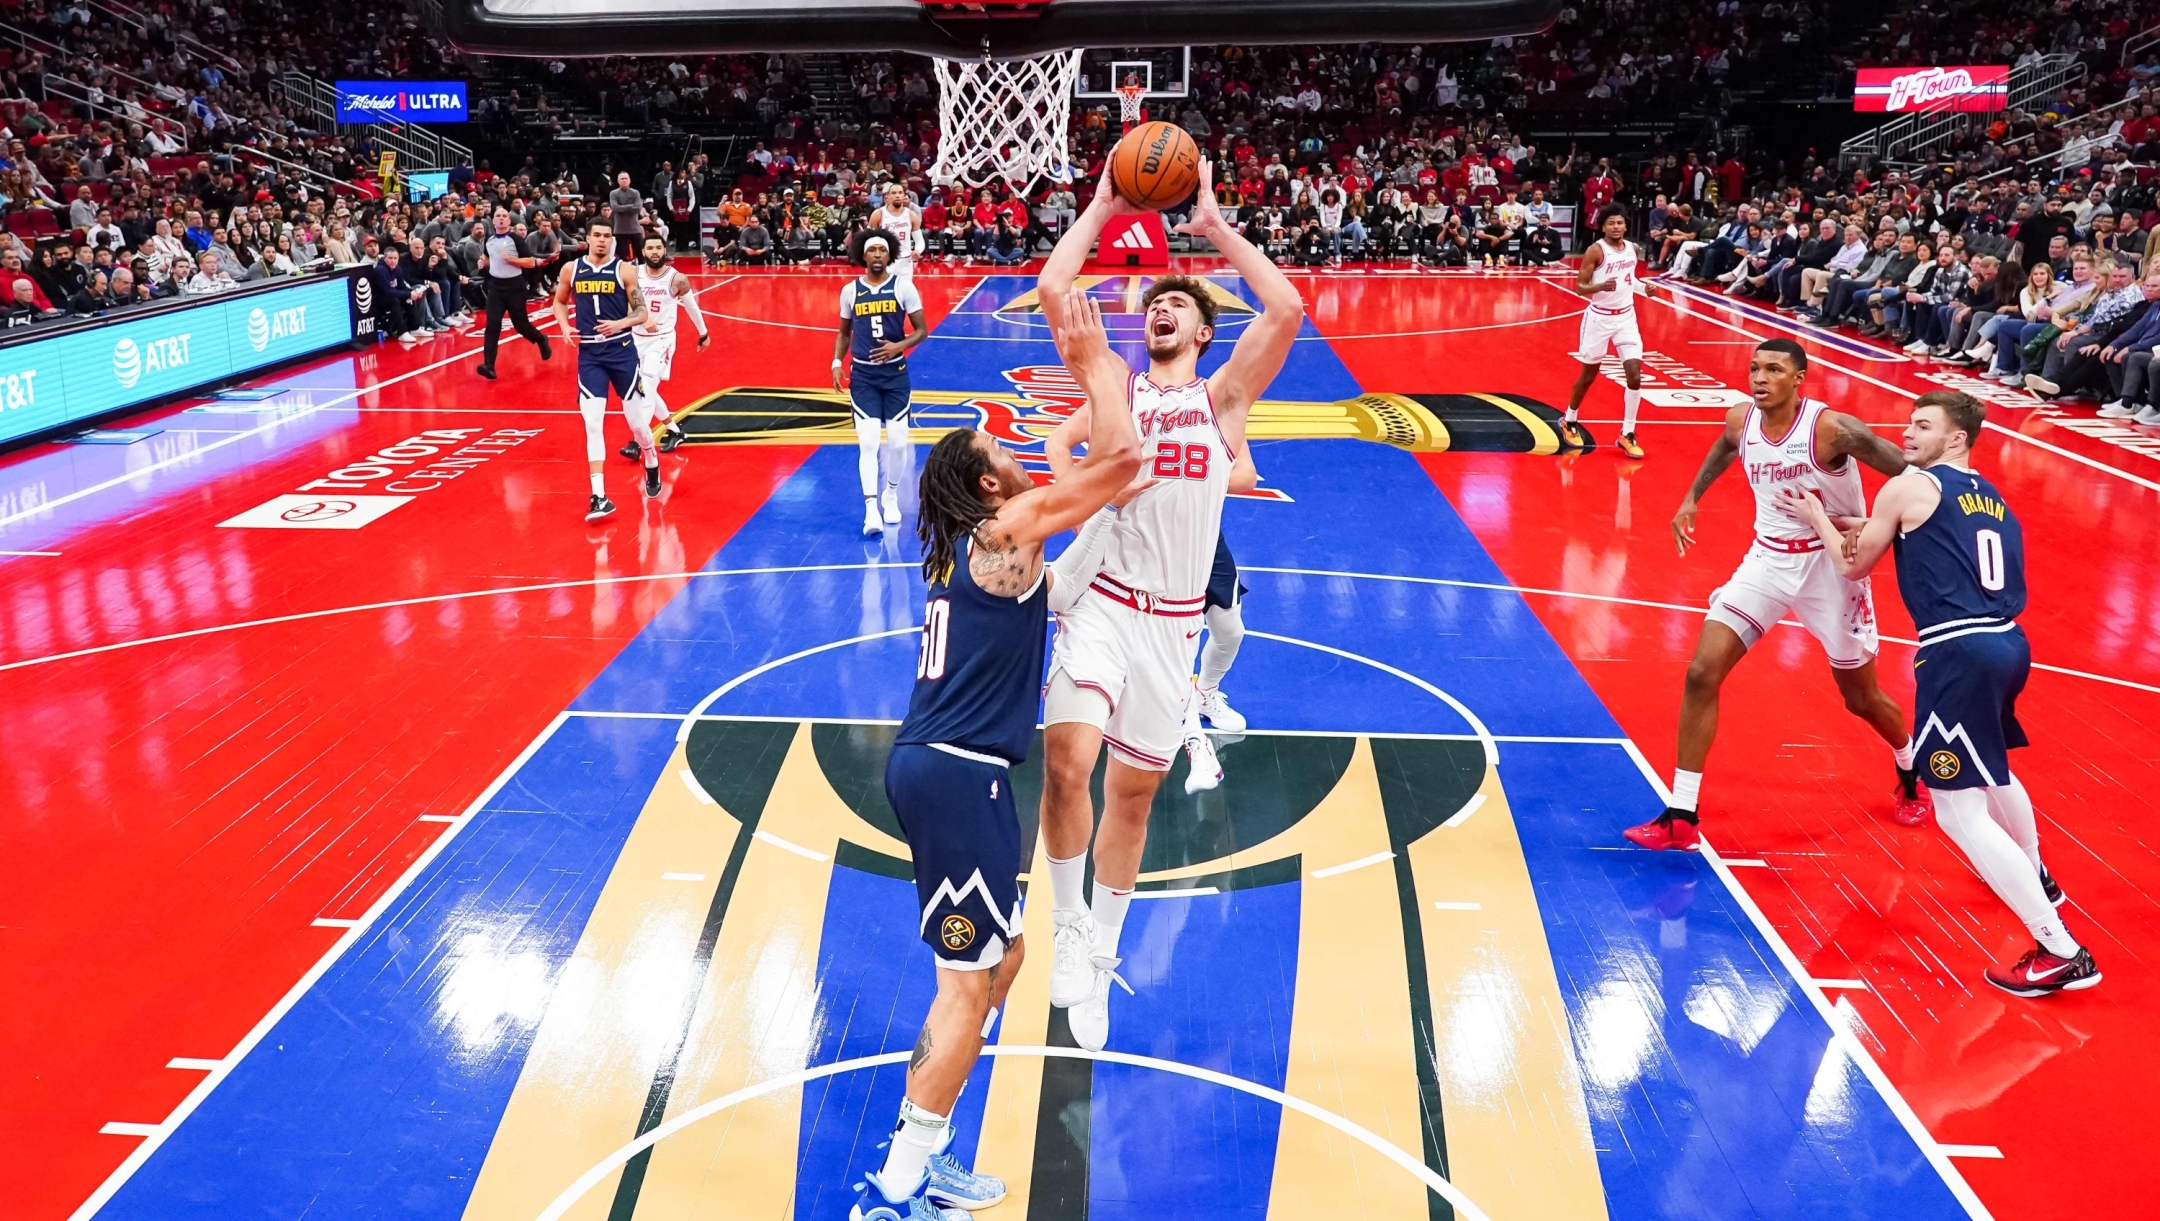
[1912,625,2033,789]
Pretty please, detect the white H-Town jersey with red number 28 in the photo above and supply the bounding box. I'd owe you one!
[1102,374,1236,603]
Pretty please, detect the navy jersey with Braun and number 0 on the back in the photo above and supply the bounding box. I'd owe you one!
[1890,462,2024,633]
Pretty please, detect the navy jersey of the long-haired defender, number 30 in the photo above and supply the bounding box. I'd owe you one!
[894,538,1050,763]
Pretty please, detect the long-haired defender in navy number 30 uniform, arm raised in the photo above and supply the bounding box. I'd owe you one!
[849,292,1153,1221]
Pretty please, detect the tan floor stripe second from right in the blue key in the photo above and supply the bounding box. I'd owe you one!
[1268,737,1430,1221]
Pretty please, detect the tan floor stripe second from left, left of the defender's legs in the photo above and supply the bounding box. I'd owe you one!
[635,724,914,1221]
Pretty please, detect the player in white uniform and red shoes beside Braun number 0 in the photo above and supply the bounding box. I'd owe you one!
[1624,339,1927,849]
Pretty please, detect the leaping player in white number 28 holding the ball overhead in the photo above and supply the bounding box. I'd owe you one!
[1037,152,1305,1050]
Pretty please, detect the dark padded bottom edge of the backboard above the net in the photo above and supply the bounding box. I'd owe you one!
[415,0,1560,58]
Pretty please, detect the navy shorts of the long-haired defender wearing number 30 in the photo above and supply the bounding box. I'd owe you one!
[886,746,1022,970]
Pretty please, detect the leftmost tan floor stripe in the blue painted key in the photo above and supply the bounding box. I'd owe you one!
[451,746,741,1221]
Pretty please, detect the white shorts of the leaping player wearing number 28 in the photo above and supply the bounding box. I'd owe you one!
[1043,590,1205,771]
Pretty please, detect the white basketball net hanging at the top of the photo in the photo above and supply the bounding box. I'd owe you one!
[931,50,1080,186]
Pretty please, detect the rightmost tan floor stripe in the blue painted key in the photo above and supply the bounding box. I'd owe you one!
[1410,769,1605,1221]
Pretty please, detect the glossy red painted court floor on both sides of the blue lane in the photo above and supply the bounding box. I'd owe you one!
[0,259,2160,1219]
